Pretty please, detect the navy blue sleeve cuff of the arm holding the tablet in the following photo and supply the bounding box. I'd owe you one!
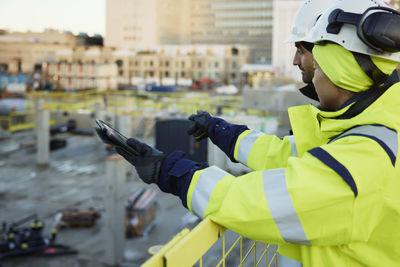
[157,151,208,208]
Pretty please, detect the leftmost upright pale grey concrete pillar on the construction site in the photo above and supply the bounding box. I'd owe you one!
[35,99,50,166]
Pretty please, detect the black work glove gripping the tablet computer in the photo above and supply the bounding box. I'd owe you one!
[115,138,165,184]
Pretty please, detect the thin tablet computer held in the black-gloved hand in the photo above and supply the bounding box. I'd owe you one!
[96,119,139,156]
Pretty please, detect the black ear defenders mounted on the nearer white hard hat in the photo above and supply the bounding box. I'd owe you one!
[326,6,400,53]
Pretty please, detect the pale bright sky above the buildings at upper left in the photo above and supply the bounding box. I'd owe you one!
[0,0,105,36]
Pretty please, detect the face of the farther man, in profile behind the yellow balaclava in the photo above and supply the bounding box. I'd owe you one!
[293,42,314,83]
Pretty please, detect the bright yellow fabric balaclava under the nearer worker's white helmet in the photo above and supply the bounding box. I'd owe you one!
[312,43,399,93]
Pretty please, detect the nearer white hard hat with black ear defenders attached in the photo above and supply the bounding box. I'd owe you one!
[304,0,400,61]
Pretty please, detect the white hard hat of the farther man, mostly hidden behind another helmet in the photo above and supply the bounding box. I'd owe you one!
[285,0,337,43]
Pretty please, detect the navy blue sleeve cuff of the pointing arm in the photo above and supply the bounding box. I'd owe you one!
[208,117,249,162]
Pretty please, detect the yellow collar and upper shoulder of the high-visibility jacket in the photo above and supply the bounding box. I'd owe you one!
[289,83,400,156]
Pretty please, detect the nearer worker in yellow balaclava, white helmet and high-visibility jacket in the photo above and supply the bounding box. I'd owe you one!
[103,0,400,266]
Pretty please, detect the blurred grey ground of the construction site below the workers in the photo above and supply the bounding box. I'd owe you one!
[0,131,187,267]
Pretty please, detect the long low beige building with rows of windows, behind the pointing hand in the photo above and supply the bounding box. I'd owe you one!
[114,45,248,86]
